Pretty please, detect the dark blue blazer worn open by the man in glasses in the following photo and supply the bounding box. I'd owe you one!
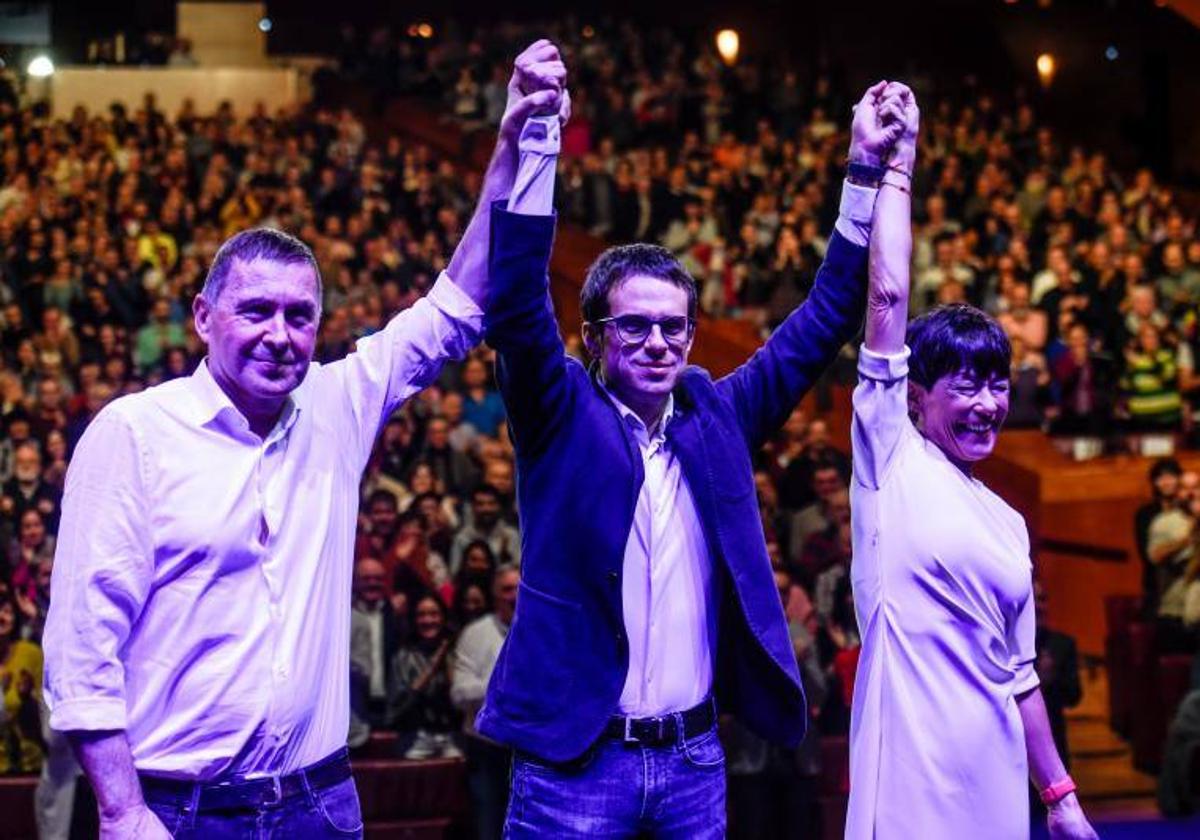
[476,205,866,761]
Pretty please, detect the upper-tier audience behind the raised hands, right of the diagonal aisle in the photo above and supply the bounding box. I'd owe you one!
[342,19,1200,438]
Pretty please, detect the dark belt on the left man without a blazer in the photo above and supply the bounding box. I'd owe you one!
[138,746,350,811]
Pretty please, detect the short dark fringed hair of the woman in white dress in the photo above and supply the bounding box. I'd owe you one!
[906,304,1013,388]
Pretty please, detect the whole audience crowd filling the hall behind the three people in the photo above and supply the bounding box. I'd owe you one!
[0,11,1200,836]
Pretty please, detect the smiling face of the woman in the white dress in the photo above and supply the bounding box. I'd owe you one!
[910,370,1008,467]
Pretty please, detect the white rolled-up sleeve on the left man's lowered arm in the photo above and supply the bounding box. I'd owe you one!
[42,407,154,731]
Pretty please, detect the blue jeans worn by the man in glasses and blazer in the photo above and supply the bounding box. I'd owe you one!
[504,727,725,840]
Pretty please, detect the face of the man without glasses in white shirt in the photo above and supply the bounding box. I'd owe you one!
[194,259,320,407]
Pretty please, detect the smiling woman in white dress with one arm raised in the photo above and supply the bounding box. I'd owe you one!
[846,84,1096,840]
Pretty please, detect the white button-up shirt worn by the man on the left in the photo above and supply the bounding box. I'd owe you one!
[44,276,482,780]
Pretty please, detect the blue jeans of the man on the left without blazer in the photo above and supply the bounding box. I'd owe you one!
[146,776,362,840]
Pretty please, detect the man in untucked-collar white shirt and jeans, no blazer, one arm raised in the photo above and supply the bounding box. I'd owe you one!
[44,48,562,838]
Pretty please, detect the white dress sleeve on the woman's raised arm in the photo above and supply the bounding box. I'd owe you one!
[851,347,912,490]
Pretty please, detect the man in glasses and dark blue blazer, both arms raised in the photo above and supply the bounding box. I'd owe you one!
[476,55,890,838]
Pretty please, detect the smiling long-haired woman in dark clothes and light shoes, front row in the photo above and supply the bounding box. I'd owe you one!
[388,592,462,760]
